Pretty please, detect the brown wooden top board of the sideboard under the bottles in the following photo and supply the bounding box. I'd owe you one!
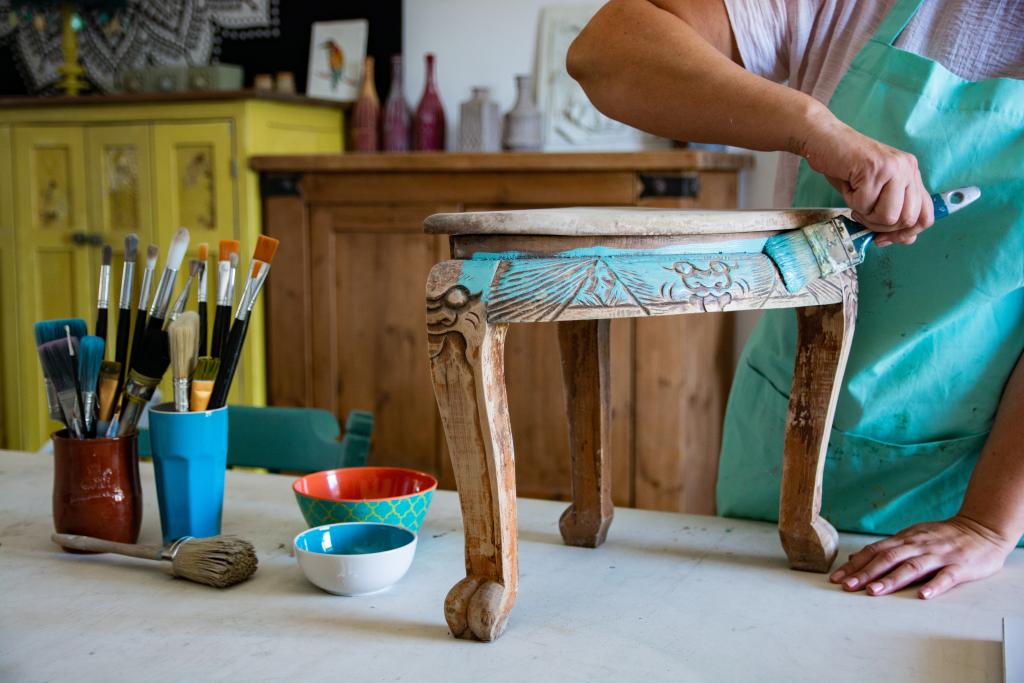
[249,150,754,173]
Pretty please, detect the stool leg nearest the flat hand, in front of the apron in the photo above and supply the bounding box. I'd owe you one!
[778,283,857,571]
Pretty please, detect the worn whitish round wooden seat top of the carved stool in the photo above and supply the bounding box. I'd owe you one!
[424,204,844,237]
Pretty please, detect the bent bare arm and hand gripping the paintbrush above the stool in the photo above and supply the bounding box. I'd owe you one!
[566,0,933,241]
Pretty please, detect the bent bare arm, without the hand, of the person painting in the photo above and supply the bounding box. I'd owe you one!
[567,0,836,154]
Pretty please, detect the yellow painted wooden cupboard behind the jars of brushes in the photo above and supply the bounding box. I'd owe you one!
[0,93,343,450]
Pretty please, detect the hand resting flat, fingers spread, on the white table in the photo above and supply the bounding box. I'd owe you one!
[828,515,1015,600]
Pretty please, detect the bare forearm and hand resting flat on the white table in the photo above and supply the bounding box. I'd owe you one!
[830,356,1024,599]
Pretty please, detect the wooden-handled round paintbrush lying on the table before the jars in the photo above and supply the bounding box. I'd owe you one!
[50,533,258,588]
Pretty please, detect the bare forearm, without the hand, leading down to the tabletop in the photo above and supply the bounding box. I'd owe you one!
[959,355,1024,545]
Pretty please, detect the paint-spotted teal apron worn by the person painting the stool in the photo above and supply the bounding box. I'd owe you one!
[718,0,1024,533]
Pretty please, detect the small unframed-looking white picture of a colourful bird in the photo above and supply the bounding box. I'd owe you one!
[306,19,370,102]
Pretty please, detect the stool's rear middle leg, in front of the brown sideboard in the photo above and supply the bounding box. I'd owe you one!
[558,321,614,548]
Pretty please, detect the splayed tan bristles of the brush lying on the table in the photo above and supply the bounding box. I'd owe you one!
[171,536,259,588]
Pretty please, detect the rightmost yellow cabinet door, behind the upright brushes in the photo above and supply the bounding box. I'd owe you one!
[153,121,238,402]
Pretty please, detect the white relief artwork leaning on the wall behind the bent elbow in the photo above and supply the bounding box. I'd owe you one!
[536,2,671,152]
